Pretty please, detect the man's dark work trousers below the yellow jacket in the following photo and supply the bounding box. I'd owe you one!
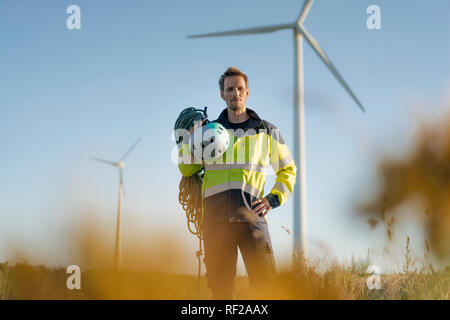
[203,221,275,300]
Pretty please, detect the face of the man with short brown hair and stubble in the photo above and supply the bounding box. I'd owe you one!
[220,76,248,111]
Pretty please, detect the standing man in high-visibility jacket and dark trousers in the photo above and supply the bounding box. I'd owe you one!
[179,67,297,299]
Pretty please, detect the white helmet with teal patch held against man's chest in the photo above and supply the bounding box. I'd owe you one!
[189,122,230,161]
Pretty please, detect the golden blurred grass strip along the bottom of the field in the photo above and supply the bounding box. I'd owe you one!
[0,262,450,300]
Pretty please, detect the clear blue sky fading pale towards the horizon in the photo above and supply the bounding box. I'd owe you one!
[0,0,450,272]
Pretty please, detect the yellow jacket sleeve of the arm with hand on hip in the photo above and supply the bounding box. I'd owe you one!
[266,128,297,208]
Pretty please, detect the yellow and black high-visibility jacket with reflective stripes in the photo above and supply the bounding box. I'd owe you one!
[178,108,297,223]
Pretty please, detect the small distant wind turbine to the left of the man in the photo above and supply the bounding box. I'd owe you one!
[91,138,141,270]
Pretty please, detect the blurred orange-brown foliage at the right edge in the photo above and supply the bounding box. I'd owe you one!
[358,109,450,263]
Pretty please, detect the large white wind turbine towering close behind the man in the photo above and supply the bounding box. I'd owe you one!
[187,0,366,257]
